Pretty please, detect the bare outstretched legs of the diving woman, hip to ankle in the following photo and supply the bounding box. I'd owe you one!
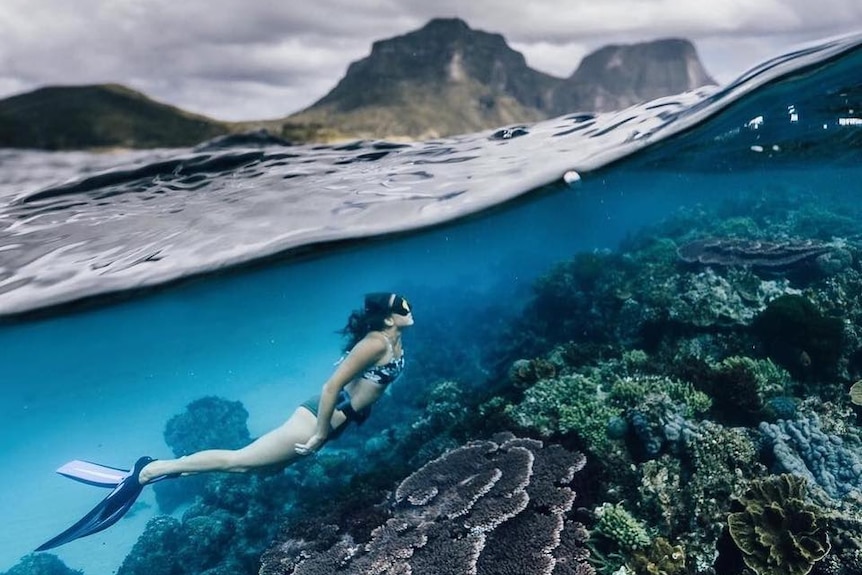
[139,407,317,483]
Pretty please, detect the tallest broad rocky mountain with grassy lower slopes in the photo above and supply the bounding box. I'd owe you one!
[288,19,559,138]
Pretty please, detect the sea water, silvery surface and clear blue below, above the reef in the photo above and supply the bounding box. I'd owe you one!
[0,32,862,573]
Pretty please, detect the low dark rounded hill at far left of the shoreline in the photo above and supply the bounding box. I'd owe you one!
[0,84,228,150]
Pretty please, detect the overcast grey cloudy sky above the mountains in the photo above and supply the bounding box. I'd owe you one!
[0,0,862,120]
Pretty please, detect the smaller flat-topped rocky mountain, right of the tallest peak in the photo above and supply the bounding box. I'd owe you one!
[552,39,716,114]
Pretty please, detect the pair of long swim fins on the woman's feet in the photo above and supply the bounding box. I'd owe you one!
[36,457,176,551]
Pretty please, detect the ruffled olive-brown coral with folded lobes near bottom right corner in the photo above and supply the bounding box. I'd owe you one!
[727,474,830,575]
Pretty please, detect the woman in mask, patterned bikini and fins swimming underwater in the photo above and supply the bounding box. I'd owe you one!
[37,292,413,551]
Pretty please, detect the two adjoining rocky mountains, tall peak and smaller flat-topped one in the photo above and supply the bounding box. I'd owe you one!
[285,19,714,138]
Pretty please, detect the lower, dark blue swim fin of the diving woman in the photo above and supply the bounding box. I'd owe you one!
[36,457,153,551]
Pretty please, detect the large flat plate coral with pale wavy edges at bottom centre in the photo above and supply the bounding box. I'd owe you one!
[261,434,595,575]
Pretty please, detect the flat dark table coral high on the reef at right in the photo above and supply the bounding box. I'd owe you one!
[677,238,832,270]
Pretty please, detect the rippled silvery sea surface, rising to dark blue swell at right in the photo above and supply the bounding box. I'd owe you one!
[0,31,862,317]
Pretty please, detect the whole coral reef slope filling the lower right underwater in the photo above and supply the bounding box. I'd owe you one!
[106,190,862,575]
